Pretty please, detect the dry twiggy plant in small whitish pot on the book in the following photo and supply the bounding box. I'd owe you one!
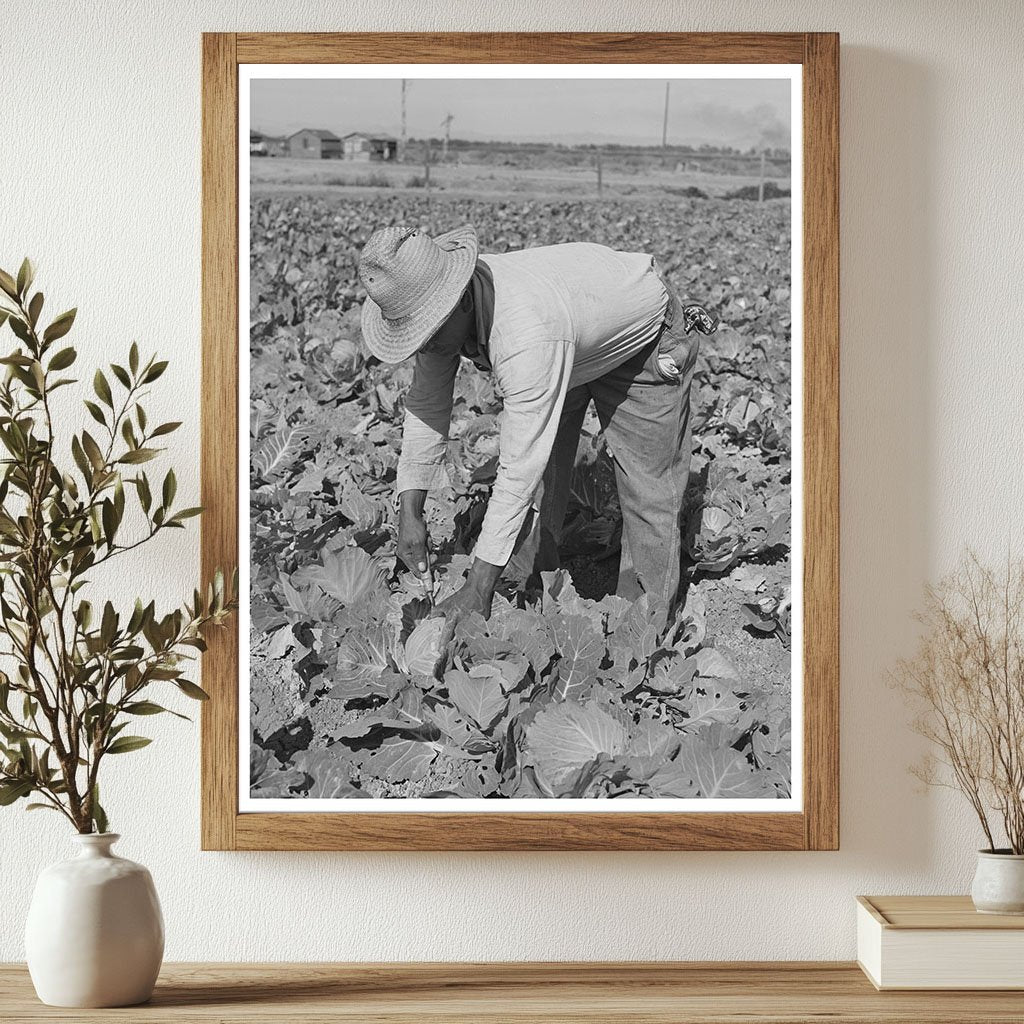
[896,554,1024,913]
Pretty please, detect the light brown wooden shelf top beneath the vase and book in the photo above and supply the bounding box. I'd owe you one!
[0,963,1024,1024]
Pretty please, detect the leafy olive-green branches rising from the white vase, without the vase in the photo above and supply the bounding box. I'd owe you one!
[0,259,238,834]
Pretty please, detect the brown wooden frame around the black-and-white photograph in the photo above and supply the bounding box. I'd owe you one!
[201,33,840,850]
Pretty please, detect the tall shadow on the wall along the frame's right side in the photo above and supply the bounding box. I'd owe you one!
[840,46,940,872]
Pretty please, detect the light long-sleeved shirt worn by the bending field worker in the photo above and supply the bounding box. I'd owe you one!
[396,242,669,565]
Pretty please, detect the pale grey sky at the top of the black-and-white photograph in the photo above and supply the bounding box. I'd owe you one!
[250,79,790,150]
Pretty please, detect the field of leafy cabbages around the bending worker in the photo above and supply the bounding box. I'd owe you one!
[249,190,792,800]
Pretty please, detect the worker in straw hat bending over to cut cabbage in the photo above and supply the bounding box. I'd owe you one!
[358,225,718,627]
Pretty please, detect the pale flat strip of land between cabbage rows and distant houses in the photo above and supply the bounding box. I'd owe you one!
[250,157,790,199]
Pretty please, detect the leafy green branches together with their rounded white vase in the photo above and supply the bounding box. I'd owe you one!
[0,260,237,1007]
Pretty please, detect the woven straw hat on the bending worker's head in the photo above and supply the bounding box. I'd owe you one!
[358,224,479,362]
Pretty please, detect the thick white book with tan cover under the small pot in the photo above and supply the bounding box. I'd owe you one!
[857,896,1024,987]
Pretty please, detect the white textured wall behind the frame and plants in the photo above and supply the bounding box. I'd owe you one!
[0,0,1024,961]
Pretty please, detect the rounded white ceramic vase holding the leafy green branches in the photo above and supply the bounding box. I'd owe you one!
[25,833,164,1007]
